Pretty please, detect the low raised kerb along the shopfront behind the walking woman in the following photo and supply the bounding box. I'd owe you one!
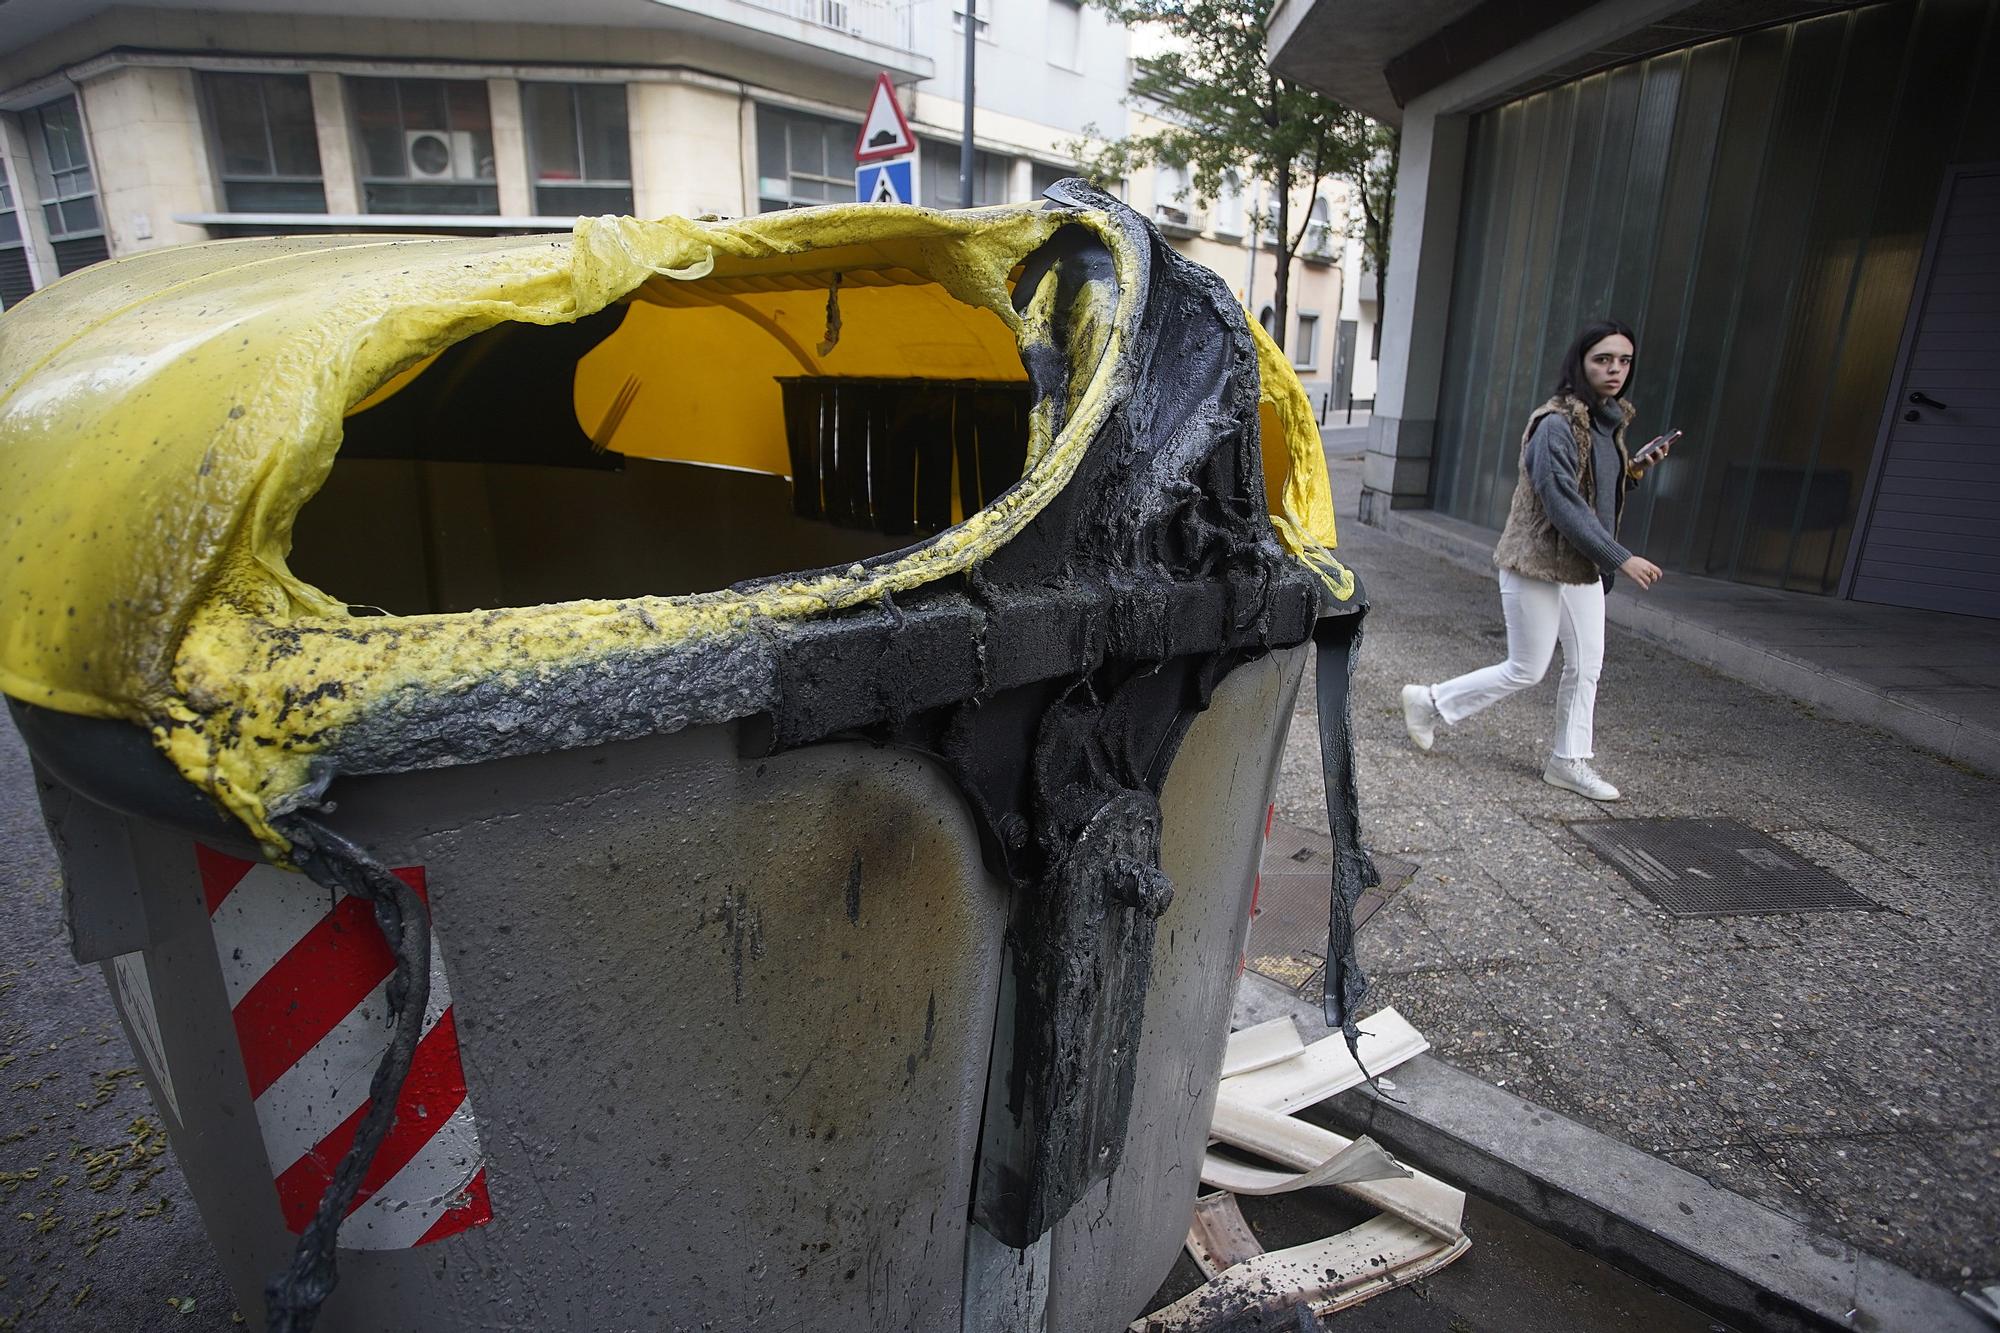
[1384,508,2000,773]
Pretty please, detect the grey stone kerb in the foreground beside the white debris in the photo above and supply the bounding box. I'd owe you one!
[1234,973,1992,1333]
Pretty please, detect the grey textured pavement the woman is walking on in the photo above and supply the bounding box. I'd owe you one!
[1278,462,2000,1287]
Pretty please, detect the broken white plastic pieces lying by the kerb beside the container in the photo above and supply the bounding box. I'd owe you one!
[1132,1009,1472,1333]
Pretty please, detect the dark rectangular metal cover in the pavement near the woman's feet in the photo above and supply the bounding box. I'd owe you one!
[1570,819,1882,917]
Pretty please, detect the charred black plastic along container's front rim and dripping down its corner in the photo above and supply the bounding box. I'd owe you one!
[7,182,1368,1296]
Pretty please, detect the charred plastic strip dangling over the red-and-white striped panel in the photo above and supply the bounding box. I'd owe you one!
[264,815,430,1333]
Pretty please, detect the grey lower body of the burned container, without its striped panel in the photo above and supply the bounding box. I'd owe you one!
[44,646,1306,1333]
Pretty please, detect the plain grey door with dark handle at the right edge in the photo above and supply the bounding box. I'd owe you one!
[1848,166,2000,616]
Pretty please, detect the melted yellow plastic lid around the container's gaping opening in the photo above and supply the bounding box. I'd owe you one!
[0,206,1352,851]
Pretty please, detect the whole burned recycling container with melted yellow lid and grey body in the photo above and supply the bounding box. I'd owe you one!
[0,182,1366,1333]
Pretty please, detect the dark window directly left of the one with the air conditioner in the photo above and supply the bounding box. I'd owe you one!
[200,72,326,212]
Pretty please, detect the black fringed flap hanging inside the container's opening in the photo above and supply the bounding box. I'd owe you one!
[778,376,1032,536]
